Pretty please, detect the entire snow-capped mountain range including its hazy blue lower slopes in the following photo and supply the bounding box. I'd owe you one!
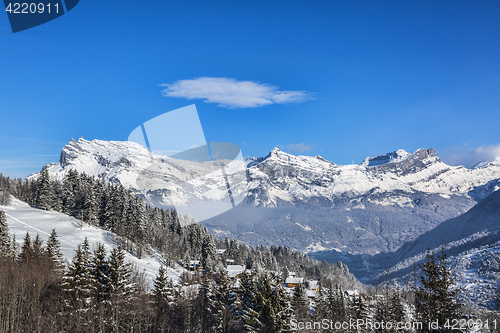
[37,139,500,254]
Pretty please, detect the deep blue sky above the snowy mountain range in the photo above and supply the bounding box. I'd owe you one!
[0,0,500,177]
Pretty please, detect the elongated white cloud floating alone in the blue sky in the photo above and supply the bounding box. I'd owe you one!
[161,77,314,109]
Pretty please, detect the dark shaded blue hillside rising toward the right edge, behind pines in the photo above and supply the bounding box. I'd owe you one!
[312,191,500,307]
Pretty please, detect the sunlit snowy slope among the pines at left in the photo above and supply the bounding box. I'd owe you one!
[0,198,181,285]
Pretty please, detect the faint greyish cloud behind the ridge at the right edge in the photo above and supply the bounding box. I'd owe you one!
[443,144,500,169]
